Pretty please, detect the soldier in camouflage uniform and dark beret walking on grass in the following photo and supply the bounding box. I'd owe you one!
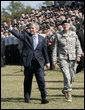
[52,21,82,102]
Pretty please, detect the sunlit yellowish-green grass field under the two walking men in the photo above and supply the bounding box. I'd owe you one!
[1,65,84,109]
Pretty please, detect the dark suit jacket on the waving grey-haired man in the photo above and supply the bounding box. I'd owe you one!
[10,29,49,67]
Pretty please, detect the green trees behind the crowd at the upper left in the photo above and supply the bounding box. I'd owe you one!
[1,1,53,23]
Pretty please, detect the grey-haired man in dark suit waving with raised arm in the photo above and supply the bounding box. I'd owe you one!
[8,19,50,104]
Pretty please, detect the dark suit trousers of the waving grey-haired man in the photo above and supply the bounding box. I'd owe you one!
[24,59,47,100]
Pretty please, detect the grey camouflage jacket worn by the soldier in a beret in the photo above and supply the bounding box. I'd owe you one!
[52,31,82,61]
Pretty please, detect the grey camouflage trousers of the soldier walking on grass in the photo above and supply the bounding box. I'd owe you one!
[59,60,77,92]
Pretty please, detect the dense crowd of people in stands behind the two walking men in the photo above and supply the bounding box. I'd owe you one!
[1,3,84,69]
